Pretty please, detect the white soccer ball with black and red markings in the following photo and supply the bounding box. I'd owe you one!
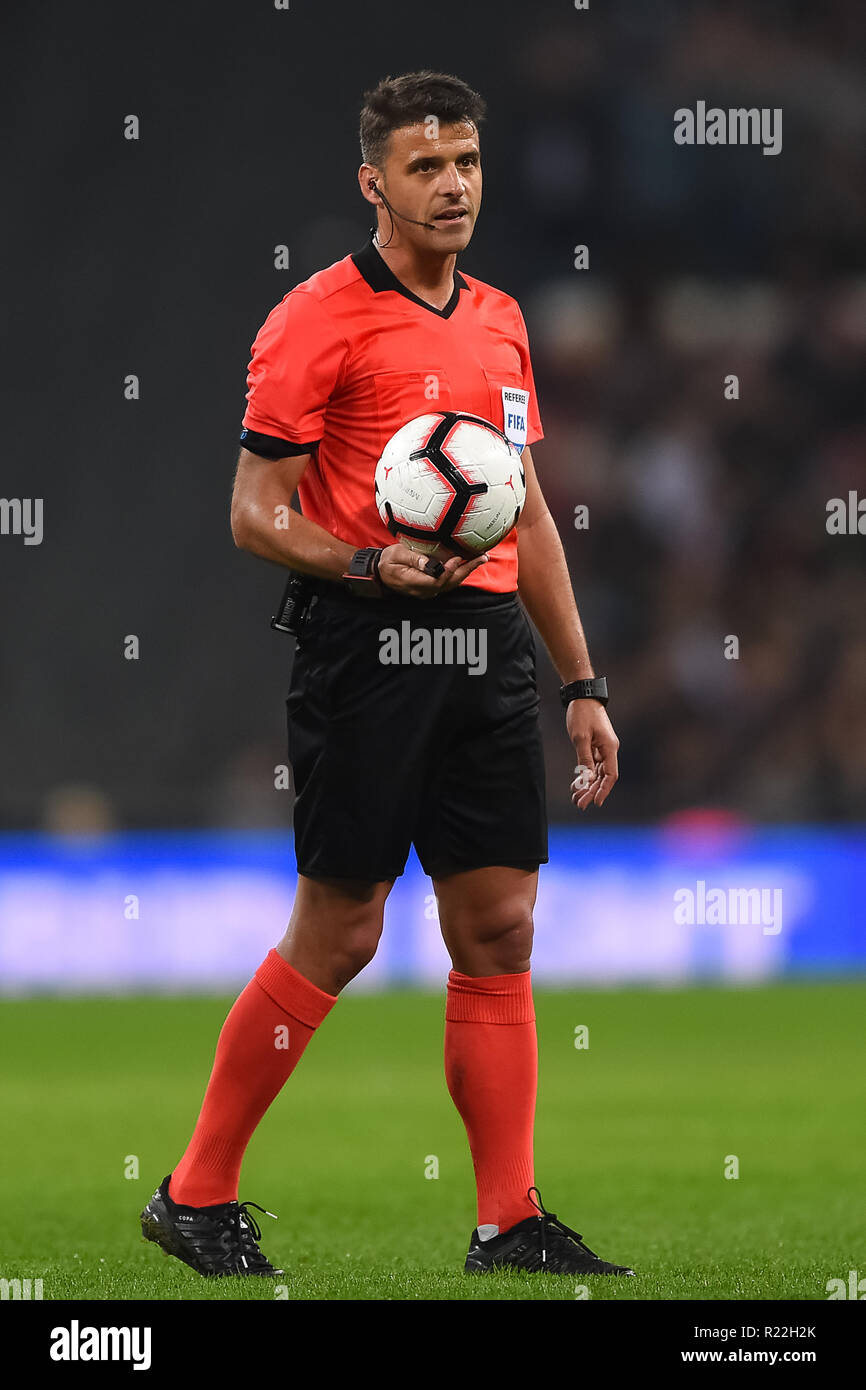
[375,410,527,559]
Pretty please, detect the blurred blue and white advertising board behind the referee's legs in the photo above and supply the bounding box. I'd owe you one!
[0,823,866,995]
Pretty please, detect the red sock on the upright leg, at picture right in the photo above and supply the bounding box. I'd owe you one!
[445,970,538,1232]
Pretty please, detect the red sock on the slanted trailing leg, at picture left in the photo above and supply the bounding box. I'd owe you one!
[168,951,336,1207]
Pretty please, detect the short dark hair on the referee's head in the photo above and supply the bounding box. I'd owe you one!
[360,70,487,168]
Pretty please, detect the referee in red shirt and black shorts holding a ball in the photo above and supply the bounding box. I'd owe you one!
[142,71,632,1276]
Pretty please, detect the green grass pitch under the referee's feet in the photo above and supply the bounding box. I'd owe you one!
[0,981,866,1300]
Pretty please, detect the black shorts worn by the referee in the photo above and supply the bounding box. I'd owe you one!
[286,589,548,881]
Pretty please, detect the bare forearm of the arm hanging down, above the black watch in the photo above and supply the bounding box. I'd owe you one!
[517,509,595,684]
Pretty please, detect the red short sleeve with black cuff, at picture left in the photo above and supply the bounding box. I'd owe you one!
[240,291,349,457]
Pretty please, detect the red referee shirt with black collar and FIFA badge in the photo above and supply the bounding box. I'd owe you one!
[240,226,544,594]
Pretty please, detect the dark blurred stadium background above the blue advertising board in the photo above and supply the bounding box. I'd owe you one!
[0,0,866,828]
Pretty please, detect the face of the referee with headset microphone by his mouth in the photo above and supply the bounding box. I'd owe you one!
[379,117,481,252]
